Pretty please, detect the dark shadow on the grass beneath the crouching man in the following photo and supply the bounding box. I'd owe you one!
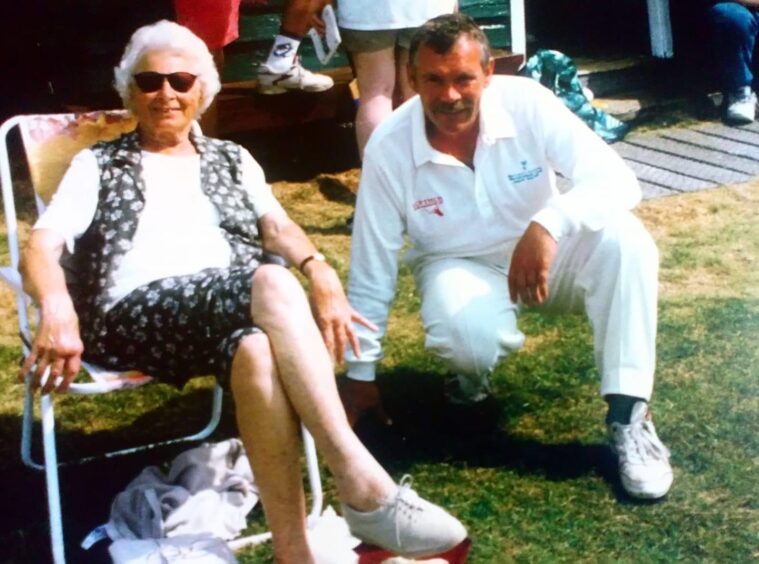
[356,370,639,503]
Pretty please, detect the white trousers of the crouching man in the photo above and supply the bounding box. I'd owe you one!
[414,213,659,399]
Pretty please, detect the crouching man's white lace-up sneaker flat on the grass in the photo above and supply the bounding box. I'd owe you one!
[609,401,672,499]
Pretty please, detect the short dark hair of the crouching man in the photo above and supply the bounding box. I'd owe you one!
[409,13,490,70]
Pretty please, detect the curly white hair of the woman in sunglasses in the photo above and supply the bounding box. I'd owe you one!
[113,20,221,117]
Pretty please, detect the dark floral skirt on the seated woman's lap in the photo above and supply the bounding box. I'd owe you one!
[83,264,261,386]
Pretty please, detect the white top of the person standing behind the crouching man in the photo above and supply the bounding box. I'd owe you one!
[337,0,456,31]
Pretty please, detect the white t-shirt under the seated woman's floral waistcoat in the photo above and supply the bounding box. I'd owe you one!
[34,145,279,308]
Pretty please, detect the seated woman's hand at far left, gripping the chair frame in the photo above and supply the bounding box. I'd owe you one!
[19,295,84,394]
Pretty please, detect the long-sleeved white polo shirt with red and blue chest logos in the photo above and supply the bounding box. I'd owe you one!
[347,76,640,380]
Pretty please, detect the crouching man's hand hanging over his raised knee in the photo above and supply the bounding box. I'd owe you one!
[509,221,557,306]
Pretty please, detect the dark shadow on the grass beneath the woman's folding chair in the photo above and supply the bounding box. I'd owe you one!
[0,385,236,563]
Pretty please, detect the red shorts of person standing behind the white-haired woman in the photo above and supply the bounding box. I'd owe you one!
[174,0,240,49]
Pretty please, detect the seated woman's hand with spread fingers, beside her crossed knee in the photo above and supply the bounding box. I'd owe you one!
[304,260,377,363]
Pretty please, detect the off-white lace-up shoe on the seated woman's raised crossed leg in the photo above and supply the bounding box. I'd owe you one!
[342,475,466,558]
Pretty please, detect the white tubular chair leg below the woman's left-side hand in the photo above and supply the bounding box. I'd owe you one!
[40,394,66,564]
